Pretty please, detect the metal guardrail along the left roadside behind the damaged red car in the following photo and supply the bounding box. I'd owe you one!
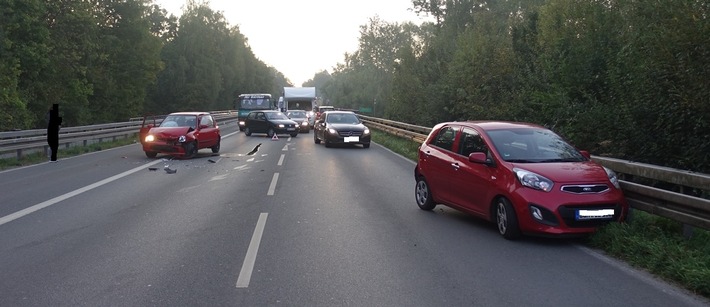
[0,111,237,159]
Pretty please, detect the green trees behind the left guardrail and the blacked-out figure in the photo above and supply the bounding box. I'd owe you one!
[0,0,288,131]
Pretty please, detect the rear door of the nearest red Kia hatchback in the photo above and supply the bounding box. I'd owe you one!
[422,125,460,206]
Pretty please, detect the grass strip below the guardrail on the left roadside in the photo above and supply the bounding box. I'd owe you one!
[0,138,136,170]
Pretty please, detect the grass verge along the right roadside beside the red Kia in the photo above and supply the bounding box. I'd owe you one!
[371,129,710,298]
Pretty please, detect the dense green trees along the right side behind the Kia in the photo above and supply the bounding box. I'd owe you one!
[309,0,710,173]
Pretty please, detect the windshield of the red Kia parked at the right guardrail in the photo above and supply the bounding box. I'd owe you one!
[488,128,586,163]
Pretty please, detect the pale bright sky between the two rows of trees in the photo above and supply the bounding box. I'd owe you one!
[155,0,422,86]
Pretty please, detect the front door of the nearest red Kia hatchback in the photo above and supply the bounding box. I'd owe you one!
[449,127,495,215]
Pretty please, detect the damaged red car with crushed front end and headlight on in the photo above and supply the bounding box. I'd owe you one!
[140,112,222,158]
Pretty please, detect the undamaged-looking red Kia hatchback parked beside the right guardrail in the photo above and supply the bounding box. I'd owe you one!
[414,121,628,239]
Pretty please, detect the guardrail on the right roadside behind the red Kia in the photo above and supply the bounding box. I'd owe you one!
[360,115,710,230]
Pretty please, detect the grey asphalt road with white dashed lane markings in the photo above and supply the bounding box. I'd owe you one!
[0,125,710,307]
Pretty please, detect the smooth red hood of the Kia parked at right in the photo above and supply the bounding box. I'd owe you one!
[513,161,609,183]
